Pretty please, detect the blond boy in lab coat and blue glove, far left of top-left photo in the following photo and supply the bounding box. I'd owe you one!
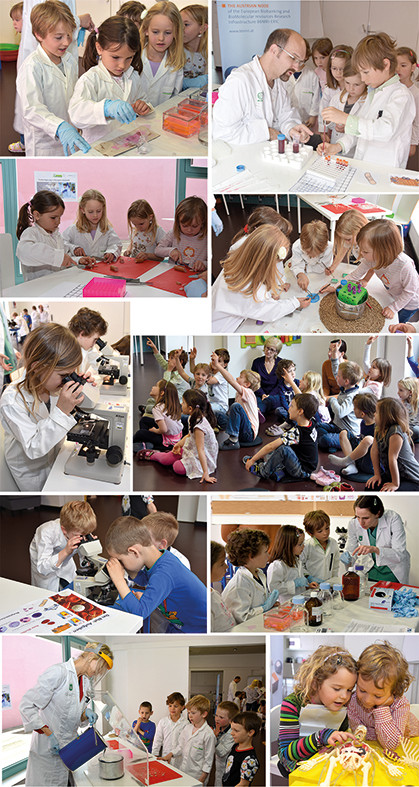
[16,0,90,156]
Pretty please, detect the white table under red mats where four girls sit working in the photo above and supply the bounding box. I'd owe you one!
[2,262,183,299]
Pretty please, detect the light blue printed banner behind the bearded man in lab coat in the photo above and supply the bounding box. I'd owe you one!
[217,0,300,77]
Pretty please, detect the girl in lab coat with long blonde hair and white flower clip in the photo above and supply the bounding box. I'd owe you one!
[212,224,310,333]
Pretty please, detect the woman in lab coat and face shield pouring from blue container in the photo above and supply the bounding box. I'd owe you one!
[19,642,113,787]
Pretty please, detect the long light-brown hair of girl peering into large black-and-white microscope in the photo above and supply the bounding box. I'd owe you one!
[16,322,82,412]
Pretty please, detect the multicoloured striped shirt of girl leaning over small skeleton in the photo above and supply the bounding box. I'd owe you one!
[278,694,348,772]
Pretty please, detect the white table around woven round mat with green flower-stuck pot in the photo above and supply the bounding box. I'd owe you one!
[230,263,398,335]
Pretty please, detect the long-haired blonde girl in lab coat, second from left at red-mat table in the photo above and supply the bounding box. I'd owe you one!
[63,189,122,262]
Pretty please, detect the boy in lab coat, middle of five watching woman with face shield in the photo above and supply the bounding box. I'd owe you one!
[164,694,215,784]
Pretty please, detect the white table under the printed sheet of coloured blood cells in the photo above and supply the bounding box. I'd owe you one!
[0,577,143,636]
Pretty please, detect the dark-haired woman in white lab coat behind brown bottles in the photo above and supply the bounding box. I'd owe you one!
[341,495,410,584]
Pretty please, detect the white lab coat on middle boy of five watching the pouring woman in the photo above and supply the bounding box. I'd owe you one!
[173,721,215,784]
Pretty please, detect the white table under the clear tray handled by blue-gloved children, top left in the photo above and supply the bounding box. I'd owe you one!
[73,88,208,158]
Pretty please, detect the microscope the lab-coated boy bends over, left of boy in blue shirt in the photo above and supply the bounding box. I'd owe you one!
[73,533,118,607]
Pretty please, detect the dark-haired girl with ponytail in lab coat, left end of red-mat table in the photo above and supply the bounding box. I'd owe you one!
[16,191,74,281]
